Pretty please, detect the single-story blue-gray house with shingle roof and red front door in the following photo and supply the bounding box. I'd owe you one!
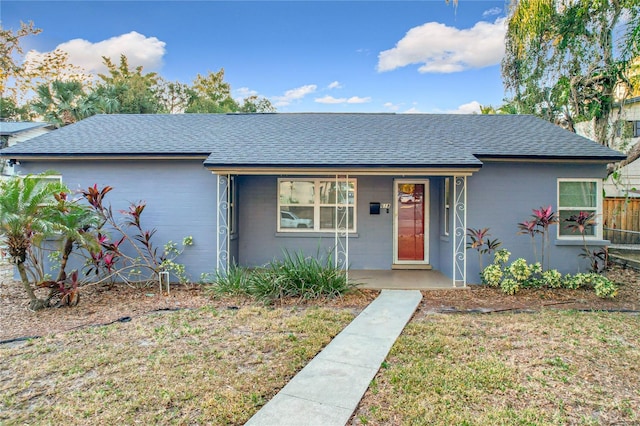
[0,113,624,285]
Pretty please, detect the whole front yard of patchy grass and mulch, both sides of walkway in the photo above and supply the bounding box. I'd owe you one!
[0,270,640,425]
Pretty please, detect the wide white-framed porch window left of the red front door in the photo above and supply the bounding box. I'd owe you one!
[278,178,356,232]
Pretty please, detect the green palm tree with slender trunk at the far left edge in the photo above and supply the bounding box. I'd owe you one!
[0,176,68,310]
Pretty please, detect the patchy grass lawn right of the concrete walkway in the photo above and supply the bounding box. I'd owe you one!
[352,310,640,425]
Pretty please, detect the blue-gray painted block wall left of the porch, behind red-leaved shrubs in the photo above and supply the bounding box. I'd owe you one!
[16,160,217,281]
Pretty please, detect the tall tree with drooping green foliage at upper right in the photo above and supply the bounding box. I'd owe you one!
[502,0,640,146]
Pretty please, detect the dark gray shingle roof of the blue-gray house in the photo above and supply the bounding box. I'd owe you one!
[0,113,624,167]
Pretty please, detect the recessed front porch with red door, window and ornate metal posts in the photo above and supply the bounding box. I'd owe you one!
[216,170,467,289]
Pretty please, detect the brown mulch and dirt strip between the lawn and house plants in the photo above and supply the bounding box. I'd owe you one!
[0,267,640,340]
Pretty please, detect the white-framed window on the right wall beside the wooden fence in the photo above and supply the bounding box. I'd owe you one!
[558,179,602,239]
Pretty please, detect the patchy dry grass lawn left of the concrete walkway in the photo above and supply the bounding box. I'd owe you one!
[0,306,354,425]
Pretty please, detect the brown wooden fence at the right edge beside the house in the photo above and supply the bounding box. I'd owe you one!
[602,197,640,244]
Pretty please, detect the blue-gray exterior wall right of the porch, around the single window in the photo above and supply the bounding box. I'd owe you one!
[467,161,606,283]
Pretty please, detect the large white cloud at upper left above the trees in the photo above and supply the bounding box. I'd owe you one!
[25,31,166,73]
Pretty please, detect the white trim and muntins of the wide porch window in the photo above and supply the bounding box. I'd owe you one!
[276,177,358,235]
